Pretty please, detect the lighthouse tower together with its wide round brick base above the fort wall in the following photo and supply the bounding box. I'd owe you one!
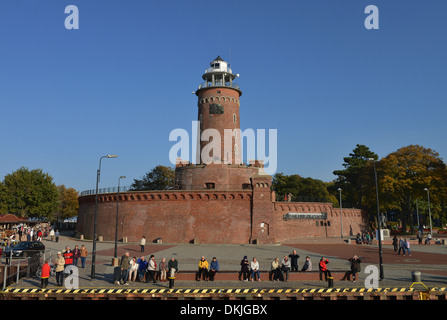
[174,57,262,190]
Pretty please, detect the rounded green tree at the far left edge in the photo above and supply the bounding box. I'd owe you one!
[0,167,58,218]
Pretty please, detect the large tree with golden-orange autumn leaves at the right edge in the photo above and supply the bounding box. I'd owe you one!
[377,145,447,232]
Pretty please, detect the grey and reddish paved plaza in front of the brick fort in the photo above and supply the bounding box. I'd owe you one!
[6,231,447,289]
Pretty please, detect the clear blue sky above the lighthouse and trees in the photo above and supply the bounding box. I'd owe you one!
[0,0,447,191]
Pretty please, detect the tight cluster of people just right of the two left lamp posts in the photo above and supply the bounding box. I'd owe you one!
[114,252,178,285]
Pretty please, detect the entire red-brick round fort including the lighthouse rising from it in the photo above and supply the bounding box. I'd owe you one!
[77,57,368,244]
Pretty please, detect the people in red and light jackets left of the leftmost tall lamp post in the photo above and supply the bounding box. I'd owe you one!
[41,245,88,288]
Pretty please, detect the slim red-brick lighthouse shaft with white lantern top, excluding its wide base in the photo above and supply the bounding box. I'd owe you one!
[196,56,242,164]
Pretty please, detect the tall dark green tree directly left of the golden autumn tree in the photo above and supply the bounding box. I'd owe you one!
[329,144,379,208]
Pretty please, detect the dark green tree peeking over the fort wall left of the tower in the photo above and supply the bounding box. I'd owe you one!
[131,165,175,191]
